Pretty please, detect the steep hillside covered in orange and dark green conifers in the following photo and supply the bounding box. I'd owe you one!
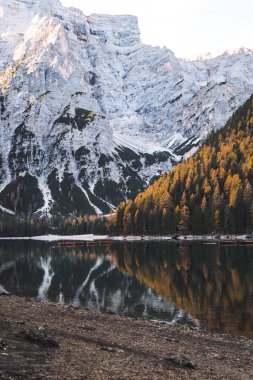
[111,96,253,234]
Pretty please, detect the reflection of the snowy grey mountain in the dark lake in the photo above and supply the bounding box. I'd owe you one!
[0,241,195,324]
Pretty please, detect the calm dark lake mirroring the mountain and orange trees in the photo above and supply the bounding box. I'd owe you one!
[0,240,253,338]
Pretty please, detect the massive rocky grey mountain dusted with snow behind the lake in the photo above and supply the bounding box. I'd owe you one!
[0,0,253,215]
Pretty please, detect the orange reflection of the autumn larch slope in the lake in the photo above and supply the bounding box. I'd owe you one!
[112,243,253,336]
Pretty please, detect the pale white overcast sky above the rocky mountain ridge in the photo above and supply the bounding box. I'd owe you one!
[61,0,253,57]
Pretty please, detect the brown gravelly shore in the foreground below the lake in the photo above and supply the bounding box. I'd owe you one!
[0,296,253,380]
